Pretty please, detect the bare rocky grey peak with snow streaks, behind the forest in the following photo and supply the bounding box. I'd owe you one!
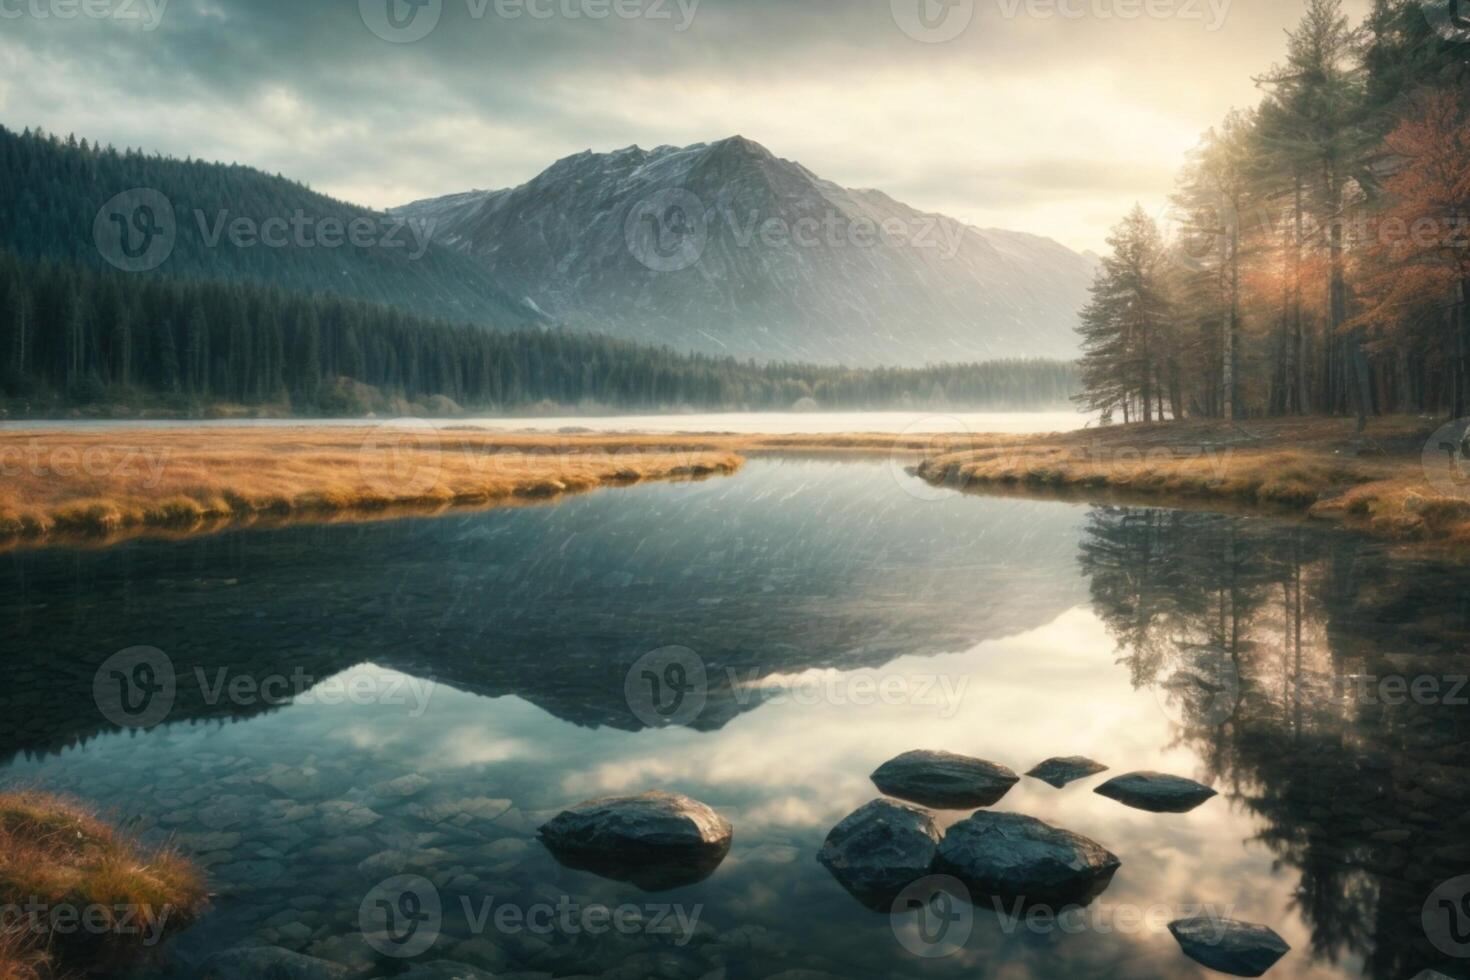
[394,137,1097,366]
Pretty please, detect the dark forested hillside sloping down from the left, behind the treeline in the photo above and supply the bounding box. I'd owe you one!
[0,126,545,328]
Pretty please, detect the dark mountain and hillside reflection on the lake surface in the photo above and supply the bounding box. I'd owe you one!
[0,464,1080,751]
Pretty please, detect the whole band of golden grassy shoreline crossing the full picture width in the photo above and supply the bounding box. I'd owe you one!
[0,417,1470,551]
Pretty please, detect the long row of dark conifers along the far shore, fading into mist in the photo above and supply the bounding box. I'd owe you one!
[0,251,1076,414]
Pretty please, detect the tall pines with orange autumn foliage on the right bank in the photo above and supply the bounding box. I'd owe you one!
[1079,0,1470,428]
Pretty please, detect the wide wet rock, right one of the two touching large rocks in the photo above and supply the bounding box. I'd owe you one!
[935,810,1122,905]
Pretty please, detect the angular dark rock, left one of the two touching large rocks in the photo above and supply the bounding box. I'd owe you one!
[817,799,939,912]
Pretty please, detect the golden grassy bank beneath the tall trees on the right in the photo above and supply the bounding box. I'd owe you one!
[917,417,1470,545]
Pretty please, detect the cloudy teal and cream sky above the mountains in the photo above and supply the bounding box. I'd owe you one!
[0,0,1369,251]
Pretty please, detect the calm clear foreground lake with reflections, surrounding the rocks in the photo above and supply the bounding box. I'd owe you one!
[0,461,1470,980]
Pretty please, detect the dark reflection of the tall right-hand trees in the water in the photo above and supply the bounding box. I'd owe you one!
[1079,508,1470,979]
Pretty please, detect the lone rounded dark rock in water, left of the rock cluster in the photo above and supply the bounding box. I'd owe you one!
[539,792,735,892]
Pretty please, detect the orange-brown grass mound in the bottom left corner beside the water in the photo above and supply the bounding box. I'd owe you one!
[0,792,207,980]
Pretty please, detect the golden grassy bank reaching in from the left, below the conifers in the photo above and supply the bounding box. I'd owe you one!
[0,423,758,544]
